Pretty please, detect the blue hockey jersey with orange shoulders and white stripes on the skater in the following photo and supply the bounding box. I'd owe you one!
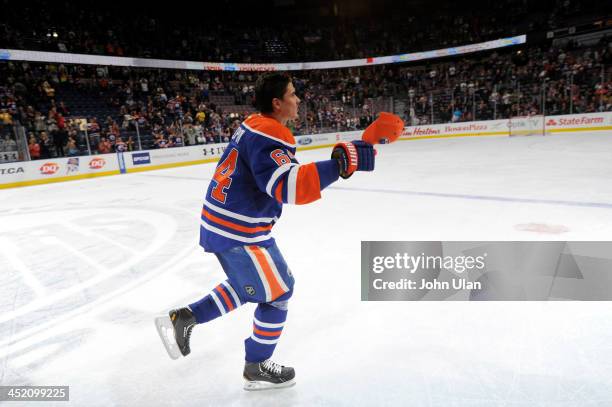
[200,114,339,252]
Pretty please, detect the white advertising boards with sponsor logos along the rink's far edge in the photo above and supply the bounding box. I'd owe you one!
[0,112,612,189]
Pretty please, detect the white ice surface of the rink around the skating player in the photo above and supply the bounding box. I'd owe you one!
[0,134,612,407]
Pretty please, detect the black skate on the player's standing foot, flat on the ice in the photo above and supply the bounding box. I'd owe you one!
[244,359,295,390]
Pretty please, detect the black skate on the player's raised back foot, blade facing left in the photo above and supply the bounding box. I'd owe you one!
[155,307,196,359]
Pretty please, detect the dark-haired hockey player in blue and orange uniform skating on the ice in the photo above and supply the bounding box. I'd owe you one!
[156,73,375,390]
